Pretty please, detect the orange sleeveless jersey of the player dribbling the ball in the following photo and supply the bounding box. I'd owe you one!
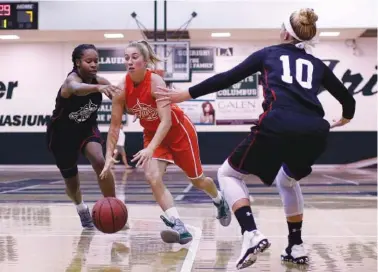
[125,70,184,131]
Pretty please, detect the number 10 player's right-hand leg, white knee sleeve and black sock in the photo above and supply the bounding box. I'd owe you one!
[275,164,309,264]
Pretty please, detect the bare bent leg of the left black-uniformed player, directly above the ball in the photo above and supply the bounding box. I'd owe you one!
[84,141,115,197]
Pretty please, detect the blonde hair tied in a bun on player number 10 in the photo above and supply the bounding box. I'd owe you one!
[290,8,318,41]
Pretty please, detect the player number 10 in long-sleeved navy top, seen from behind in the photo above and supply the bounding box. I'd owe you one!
[157,9,355,269]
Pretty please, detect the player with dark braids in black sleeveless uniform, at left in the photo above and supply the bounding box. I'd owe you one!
[47,44,120,229]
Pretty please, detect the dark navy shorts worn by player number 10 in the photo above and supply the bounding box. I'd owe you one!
[228,109,329,186]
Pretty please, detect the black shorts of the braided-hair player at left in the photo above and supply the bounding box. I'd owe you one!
[47,126,103,172]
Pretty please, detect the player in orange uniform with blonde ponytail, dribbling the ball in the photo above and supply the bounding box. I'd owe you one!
[101,41,231,244]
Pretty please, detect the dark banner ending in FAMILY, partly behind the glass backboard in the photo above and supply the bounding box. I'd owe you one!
[173,47,215,72]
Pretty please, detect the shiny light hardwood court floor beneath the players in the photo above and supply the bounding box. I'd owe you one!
[0,168,377,272]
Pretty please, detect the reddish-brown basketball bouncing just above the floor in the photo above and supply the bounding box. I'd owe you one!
[92,197,128,233]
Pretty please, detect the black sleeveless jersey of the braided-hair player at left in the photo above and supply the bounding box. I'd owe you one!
[51,70,102,130]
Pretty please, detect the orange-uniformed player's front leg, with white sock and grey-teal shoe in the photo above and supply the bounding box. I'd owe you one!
[144,159,193,244]
